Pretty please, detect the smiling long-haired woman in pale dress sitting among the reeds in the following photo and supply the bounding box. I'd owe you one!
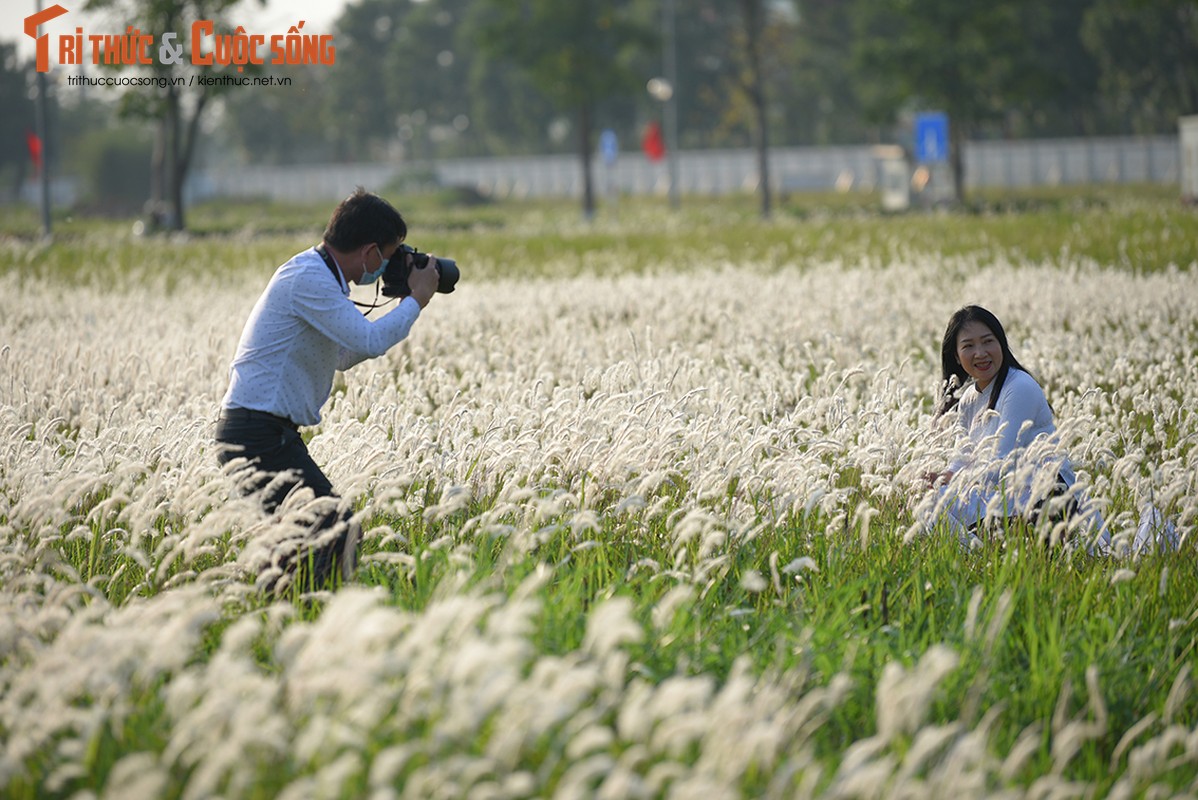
[924,305,1109,547]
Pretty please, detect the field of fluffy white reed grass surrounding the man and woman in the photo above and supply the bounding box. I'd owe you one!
[0,246,1198,800]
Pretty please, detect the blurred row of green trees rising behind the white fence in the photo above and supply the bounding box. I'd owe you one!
[7,0,1198,211]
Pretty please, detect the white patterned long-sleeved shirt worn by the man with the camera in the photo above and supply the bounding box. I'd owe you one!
[220,248,420,425]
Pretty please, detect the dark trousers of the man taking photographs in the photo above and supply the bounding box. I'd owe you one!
[216,408,357,593]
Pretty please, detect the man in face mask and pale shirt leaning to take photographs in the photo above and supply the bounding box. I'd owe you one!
[216,188,440,592]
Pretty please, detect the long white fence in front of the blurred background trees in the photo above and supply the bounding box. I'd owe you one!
[188,137,1180,199]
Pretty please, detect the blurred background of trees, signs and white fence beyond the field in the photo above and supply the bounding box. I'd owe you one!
[0,0,1198,230]
